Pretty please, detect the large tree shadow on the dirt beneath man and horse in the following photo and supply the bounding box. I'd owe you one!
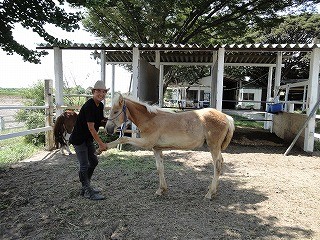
[0,127,313,240]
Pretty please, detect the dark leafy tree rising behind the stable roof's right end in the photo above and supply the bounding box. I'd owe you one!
[227,13,320,87]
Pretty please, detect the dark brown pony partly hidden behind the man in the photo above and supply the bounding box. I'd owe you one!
[53,110,78,155]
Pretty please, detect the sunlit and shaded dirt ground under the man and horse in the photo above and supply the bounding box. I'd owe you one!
[0,126,320,240]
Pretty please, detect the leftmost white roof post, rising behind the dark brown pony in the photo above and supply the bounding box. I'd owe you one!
[53,47,64,116]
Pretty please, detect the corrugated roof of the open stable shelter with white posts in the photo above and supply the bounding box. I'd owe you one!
[37,43,320,64]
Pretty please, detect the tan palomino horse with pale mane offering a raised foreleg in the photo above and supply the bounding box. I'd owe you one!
[106,94,235,199]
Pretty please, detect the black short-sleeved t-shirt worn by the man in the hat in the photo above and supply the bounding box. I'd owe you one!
[69,98,104,145]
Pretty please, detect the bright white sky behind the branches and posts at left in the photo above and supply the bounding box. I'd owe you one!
[0,7,131,93]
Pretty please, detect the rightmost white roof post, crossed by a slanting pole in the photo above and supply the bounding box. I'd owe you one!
[303,48,320,152]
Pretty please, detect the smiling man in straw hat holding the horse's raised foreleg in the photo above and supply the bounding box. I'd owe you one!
[69,81,109,200]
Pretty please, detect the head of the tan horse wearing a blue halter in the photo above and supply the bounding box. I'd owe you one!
[106,93,127,134]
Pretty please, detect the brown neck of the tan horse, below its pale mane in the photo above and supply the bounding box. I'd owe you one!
[126,101,151,126]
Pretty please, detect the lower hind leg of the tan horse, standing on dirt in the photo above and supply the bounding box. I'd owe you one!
[205,149,223,199]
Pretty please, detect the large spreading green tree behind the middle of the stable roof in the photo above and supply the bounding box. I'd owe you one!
[83,0,320,89]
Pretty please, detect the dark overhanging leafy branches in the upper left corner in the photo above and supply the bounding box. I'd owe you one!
[0,0,82,63]
